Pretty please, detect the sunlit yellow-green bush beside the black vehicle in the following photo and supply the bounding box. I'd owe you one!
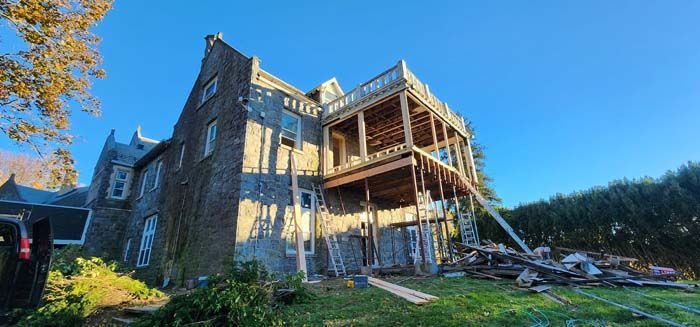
[18,247,163,326]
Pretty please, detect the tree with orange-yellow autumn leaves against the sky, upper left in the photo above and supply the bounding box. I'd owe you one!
[0,0,112,186]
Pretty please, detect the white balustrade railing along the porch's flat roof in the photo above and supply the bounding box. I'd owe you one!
[323,60,466,133]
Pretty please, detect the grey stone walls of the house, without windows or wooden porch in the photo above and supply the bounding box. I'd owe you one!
[78,36,426,285]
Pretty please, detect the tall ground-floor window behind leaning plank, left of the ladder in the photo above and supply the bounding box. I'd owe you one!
[286,190,316,255]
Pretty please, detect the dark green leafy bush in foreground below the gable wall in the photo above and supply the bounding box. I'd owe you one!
[135,260,311,327]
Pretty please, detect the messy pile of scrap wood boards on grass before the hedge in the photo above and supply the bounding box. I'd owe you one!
[443,243,697,289]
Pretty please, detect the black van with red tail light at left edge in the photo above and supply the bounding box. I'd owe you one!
[0,215,53,323]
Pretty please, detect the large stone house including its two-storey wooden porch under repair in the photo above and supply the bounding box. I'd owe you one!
[75,34,477,285]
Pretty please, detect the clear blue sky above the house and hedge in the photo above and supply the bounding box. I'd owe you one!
[0,0,700,206]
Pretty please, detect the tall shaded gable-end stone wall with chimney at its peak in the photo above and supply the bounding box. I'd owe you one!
[157,41,252,284]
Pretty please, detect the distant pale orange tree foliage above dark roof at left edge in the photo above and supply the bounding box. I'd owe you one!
[0,150,49,189]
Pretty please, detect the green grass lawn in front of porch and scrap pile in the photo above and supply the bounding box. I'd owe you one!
[281,277,700,326]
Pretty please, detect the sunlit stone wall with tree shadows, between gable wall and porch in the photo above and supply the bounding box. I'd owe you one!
[236,73,321,273]
